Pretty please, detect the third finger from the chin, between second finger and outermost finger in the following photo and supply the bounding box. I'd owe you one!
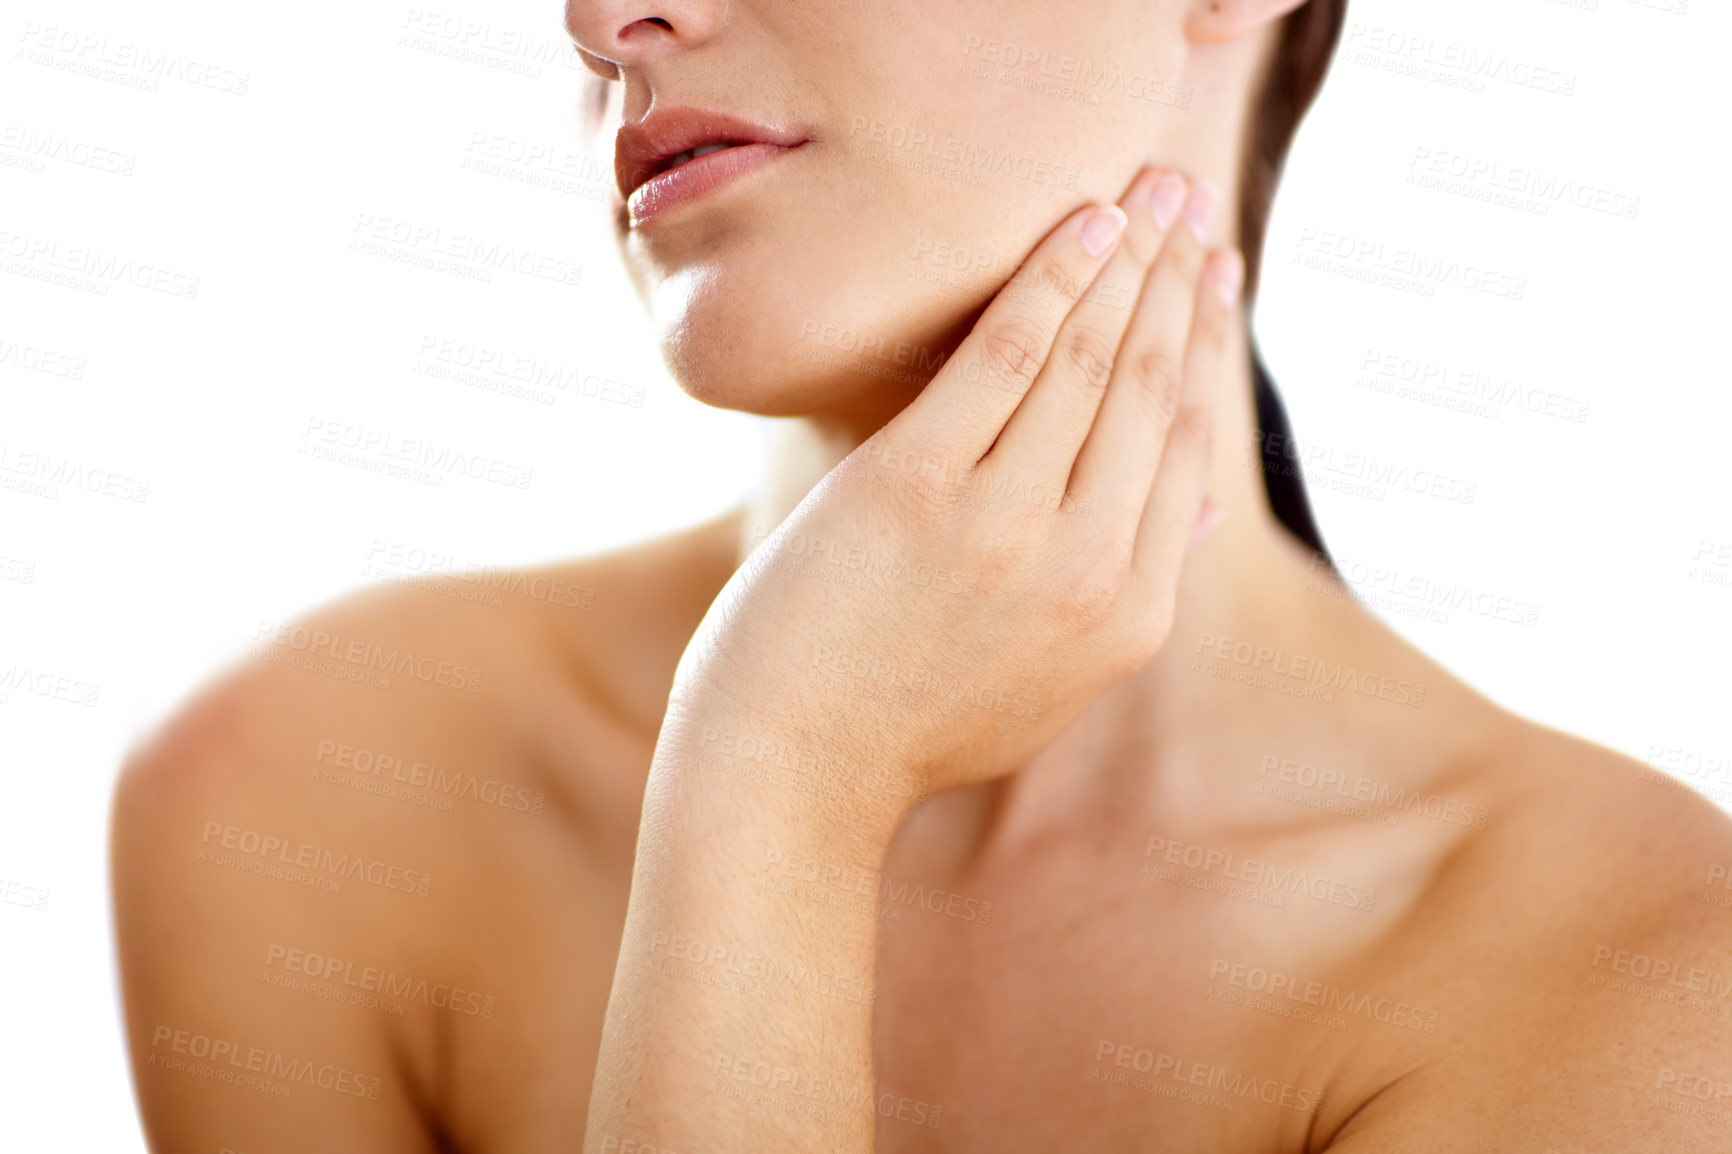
[1069,184,1219,518]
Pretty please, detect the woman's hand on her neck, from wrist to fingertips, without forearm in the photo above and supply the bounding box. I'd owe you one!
[670,172,1244,803]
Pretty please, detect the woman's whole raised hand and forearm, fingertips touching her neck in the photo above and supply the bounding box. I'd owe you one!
[584,173,1240,1154]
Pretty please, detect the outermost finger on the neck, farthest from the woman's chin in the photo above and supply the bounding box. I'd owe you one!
[1131,251,1245,589]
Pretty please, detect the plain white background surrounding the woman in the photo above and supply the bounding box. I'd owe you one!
[0,0,1732,1151]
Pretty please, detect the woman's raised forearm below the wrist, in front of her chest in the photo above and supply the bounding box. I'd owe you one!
[585,696,913,1154]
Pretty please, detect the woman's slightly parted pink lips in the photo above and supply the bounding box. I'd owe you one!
[613,107,809,224]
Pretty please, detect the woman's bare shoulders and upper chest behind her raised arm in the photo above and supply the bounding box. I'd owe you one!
[114,337,1732,1154]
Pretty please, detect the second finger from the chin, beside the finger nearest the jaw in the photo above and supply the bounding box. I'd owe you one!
[987,170,1186,481]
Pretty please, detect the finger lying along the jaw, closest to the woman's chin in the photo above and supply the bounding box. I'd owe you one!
[897,204,1126,463]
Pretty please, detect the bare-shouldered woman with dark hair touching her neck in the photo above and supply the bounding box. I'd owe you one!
[114,0,1732,1154]
